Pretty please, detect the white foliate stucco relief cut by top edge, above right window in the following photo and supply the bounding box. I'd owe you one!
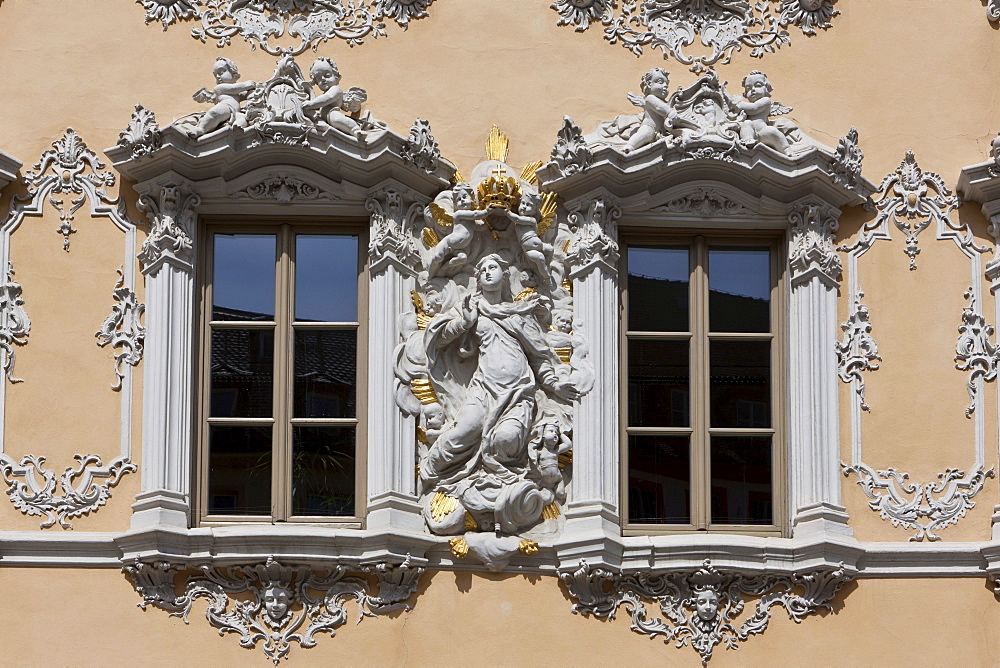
[550,0,840,72]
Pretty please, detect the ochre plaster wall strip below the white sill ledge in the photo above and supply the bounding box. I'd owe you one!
[0,568,1000,668]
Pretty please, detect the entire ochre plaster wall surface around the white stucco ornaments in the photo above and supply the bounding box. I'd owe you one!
[0,0,1000,666]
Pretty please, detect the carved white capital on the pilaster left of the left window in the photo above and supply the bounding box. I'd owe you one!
[138,184,201,274]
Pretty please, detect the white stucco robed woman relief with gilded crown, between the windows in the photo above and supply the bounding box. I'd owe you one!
[396,128,593,570]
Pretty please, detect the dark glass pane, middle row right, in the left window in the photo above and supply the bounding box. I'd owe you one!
[294,329,358,417]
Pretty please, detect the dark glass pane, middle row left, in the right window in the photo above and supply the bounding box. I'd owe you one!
[628,339,691,427]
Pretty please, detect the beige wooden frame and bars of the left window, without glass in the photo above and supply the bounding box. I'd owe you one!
[192,218,368,529]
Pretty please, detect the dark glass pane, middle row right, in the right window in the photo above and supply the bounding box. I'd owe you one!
[709,341,771,427]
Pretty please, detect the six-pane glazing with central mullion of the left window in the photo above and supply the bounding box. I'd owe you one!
[201,226,359,521]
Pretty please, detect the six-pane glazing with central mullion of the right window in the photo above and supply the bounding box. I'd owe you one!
[624,239,779,532]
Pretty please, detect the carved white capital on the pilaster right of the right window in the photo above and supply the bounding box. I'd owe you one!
[788,204,841,289]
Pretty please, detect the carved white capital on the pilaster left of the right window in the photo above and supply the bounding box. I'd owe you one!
[566,197,622,278]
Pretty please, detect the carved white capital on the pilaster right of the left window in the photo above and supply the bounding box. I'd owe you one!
[365,187,422,274]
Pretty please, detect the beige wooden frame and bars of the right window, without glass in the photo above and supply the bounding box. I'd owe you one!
[619,229,788,536]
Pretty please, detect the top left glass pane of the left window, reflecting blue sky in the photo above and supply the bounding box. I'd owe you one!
[212,234,275,320]
